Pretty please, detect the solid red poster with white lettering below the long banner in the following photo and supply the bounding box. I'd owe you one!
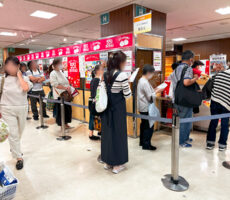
[67,57,80,88]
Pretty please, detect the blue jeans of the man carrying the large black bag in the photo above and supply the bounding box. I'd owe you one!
[174,104,193,145]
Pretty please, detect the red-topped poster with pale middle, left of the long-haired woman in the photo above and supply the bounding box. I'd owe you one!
[85,54,101,89]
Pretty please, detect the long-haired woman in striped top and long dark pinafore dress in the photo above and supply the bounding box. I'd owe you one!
[101,51,131,174]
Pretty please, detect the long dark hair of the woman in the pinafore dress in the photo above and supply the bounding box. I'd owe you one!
[107,51,127,83]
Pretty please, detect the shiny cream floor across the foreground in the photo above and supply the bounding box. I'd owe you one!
[0,117,230,200]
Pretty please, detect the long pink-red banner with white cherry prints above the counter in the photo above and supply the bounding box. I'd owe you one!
[17,33,133,62]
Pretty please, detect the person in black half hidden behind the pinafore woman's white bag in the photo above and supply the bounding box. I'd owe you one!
[89,65,104,140]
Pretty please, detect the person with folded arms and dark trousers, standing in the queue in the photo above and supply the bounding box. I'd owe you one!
[26,61,49,120]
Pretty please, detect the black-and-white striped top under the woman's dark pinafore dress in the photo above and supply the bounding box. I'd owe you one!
[107,71,132,98]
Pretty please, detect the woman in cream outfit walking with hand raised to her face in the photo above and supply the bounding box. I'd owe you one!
[0,57,33,170]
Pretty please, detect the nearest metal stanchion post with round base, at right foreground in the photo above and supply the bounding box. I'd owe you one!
[161,114,189,192]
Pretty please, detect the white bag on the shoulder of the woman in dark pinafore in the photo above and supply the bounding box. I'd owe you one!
[96,82,108,113]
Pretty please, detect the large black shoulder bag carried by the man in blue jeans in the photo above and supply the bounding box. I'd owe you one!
[175,67,202,108]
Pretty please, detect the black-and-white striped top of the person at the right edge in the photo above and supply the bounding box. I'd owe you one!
[211,69,230,111]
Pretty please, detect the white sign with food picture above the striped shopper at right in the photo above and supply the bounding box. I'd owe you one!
[210,54,227,76]
